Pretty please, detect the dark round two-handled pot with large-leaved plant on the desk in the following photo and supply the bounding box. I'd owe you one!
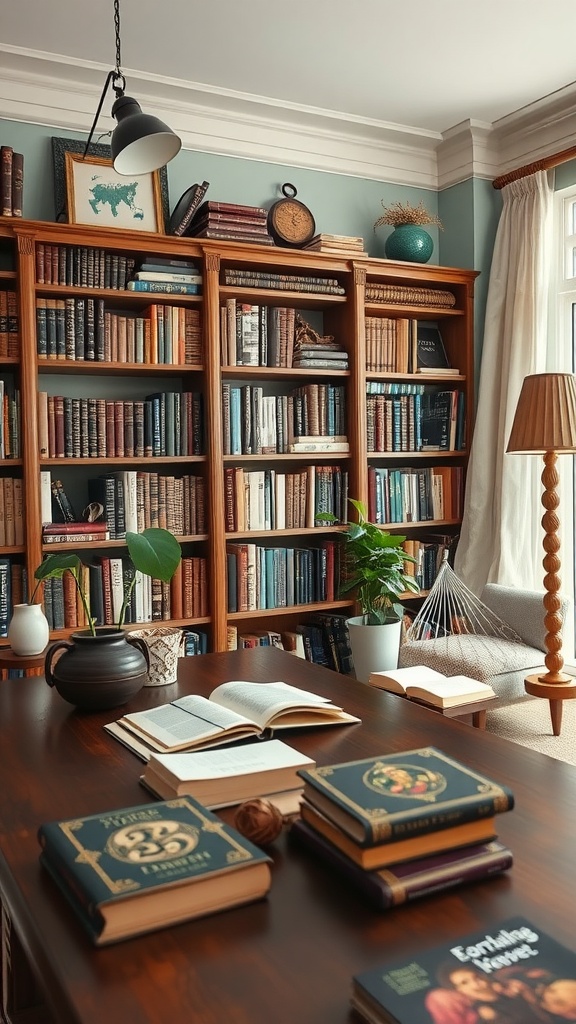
[34,527,181,711]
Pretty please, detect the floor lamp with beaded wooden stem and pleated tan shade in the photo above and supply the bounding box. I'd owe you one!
[506,373,576,736]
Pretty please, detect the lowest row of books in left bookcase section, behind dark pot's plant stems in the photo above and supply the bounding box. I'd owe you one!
[44,557,208,630]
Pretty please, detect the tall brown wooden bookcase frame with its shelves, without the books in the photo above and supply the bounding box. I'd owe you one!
[0,218,476,651]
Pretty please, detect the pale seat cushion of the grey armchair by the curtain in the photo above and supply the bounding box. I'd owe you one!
[399,634,544,686]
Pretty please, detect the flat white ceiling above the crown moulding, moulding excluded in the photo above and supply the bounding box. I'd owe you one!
[0,0,576,132]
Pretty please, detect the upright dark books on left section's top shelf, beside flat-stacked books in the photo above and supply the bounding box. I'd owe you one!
[36,242,135,292]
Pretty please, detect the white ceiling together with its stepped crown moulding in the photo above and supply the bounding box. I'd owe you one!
[0,0,576,187]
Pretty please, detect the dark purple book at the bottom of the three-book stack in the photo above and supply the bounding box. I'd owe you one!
[289,820,513,910]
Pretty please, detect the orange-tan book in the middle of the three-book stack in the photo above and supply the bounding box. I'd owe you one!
[300,800,497,870]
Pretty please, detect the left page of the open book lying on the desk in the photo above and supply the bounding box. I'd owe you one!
[120,694,257,748]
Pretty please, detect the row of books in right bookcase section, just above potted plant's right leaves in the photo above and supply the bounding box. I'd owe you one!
[368,466,463,526]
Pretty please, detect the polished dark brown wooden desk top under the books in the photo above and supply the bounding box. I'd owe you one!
[0,648,576,1024]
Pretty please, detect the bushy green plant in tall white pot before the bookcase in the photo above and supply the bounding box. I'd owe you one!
[332,499,420,682]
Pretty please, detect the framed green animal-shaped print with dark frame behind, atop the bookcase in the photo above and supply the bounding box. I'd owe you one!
[52,137,169,233]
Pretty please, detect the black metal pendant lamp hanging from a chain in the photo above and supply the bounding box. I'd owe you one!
[84,0,182,175]
